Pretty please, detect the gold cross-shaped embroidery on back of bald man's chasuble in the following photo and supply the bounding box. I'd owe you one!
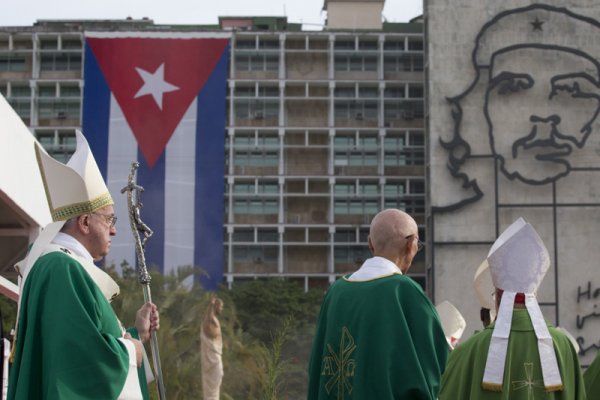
[321,327,356,400]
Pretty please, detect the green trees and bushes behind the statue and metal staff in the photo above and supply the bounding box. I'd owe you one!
[0,264,323,400]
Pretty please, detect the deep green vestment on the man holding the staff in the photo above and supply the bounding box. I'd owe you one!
[8,252,134,400]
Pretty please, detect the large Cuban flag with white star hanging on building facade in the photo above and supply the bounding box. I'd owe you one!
[83,32,230,290]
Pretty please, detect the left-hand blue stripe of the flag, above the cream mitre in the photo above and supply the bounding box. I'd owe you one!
[82,43,110,179]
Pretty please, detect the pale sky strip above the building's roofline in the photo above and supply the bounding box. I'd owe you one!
[0,0,423,30]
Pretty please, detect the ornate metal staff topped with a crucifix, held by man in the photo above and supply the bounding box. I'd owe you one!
[121,161,167,400]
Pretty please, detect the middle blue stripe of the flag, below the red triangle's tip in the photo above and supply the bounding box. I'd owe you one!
[137,150,165,272]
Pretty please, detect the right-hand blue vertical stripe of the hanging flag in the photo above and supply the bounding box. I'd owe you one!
[194,46,229,290]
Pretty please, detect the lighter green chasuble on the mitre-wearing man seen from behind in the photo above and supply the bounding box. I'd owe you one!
[439,309,586,400]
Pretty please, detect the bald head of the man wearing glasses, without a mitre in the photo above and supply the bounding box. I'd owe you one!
[369,208,419,272]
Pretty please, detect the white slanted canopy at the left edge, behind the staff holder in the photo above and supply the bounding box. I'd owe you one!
[0,95,51,298]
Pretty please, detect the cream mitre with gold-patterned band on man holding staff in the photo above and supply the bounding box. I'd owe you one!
[20,131,113,282]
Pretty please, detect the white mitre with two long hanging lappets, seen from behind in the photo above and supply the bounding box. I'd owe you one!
[482,218,563,392]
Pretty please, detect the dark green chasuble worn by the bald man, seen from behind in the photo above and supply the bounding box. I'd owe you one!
[308,274,449,400]
